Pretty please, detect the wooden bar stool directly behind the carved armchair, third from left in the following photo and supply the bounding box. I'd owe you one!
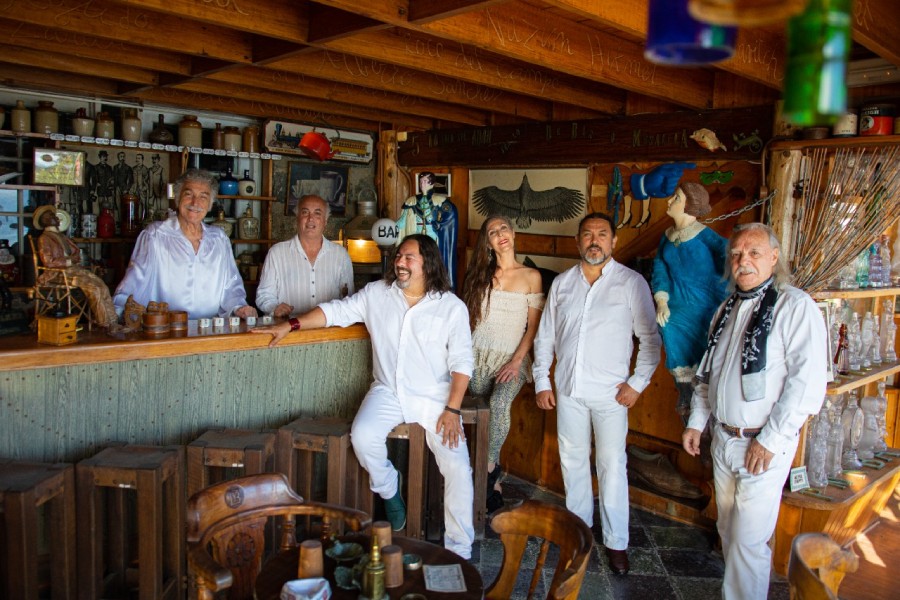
[187,429,275,498]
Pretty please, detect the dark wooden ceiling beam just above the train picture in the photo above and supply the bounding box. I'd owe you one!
[138,88,379,131]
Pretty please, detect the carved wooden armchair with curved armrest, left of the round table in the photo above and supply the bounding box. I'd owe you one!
[187,473,371,600]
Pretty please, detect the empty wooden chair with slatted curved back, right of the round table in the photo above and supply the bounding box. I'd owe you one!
[485,500,594,600]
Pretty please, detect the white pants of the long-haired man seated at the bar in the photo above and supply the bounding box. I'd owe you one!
[350,387,475,558]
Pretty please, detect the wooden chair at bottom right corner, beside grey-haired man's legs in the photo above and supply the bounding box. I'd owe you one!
[788,533,859,600]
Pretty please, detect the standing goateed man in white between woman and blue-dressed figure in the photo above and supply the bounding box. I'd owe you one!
[533,213,661,575]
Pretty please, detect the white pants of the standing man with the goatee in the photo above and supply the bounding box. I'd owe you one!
[556,395,628,550]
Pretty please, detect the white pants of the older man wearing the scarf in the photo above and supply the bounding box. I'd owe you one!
[712,425,799,600]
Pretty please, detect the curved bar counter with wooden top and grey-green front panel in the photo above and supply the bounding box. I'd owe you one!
[0,319,372,462]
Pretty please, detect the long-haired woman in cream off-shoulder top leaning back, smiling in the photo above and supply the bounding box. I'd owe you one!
[462,216,544,512]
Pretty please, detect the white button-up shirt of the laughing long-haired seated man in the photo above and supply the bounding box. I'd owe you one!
[319,281,473,423]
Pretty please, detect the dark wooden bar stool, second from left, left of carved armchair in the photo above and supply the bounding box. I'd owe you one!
[75,445,185,600]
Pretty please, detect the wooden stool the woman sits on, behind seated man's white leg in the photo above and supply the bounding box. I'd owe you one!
[425,396,491,540]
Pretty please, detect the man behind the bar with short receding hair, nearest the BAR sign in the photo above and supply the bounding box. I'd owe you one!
[256,195,354,318]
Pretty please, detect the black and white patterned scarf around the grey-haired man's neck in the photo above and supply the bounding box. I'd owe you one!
[695,277,778,402]
